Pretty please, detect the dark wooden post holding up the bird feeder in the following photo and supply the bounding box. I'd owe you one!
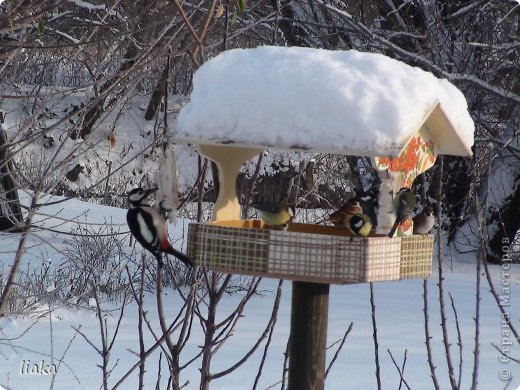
[288,282,330,390]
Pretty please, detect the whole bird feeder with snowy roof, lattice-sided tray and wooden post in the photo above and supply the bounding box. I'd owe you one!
[172,47,474,389]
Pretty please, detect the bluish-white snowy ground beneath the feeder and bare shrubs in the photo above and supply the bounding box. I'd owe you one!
[0,200,520,390]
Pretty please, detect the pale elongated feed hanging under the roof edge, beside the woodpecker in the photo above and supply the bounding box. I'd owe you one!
[157,142,179,223]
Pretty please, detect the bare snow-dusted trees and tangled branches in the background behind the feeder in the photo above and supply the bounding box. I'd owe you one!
[0,0,520,261]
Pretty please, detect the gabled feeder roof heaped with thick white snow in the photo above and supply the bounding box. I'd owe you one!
[172,46,474,156]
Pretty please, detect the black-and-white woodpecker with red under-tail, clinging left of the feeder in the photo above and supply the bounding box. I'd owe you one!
[126,188,193,267]
